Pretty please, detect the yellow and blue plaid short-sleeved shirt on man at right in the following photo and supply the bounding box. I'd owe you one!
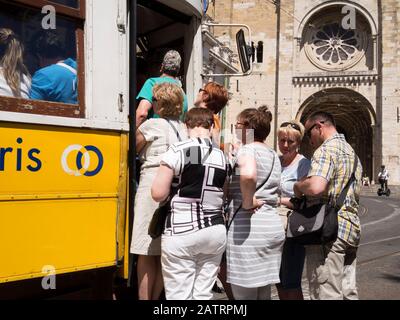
[308,134,362,247]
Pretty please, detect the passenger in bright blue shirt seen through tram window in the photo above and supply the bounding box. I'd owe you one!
[30,30,78,104]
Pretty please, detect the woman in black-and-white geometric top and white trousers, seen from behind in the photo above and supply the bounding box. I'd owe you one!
[151,108,227,300]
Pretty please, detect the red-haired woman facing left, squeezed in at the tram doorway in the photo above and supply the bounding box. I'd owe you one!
[194,82,229,148]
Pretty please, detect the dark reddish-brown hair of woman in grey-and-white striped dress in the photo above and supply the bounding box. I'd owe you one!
[237,105,272,142]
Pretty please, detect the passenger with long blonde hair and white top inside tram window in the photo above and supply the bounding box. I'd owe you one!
[0,28,31,99]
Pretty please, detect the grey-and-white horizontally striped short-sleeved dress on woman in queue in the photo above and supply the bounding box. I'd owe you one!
[226,143,285,288]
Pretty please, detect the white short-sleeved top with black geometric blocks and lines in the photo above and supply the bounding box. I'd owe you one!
[161,138,227,236]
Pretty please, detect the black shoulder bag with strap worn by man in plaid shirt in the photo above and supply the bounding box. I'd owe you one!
[286,155,358,245]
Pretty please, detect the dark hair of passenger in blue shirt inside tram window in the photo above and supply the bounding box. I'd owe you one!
[35,30,65,59]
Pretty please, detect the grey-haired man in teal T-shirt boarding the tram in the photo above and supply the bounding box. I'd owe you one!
[136,50,188,129]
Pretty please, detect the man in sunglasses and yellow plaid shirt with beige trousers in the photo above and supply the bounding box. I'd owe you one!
[294,112,362,300]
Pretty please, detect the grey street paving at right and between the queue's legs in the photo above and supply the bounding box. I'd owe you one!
[214,185,400,300]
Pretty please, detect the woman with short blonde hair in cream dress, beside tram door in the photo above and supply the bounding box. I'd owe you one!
[131,82,187,300]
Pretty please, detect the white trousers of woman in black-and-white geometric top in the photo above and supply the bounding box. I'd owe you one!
[161,225,226,300]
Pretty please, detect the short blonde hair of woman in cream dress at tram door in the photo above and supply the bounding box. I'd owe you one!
[153,82,184,119]
